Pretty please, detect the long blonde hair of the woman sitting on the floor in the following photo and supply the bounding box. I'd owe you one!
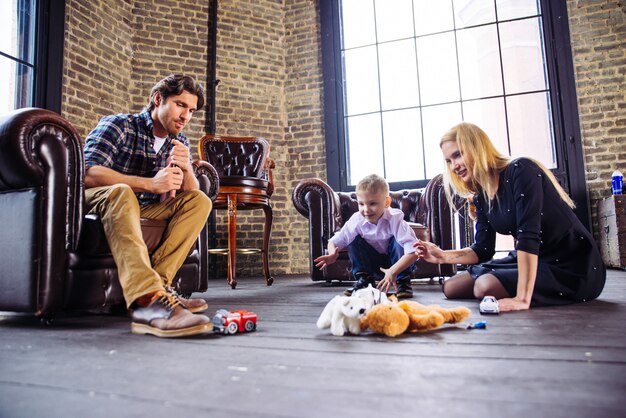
[439,122,575,208]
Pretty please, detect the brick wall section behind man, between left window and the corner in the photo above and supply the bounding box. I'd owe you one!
[62,0,133,137]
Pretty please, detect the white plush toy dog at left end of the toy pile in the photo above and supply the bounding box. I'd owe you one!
[317,295,367,336]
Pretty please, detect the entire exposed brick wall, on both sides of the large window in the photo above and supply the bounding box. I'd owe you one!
[63,0,626,277]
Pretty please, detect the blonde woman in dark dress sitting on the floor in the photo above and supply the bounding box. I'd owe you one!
[415,123,606,311]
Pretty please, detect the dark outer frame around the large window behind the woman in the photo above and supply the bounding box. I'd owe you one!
[320,0,591,228]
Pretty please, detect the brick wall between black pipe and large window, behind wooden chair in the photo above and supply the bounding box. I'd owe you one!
[210,0,326,276]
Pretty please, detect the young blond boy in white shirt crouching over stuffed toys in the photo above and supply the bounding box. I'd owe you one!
[314,174,418,299]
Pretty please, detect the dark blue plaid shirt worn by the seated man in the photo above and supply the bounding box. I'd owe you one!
[84,111,191,206]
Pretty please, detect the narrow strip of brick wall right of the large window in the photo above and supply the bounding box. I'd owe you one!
[567,0,626,233]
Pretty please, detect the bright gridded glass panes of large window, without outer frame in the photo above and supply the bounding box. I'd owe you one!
[340,0,555,185]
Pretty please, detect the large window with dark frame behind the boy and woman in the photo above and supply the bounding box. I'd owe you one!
[320,0,586,229]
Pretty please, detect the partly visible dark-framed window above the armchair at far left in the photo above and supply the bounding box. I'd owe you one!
[0,0,65,114]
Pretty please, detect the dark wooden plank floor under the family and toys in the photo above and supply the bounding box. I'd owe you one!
[0,270,626,418]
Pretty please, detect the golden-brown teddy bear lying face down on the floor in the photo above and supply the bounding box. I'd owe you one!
[361,300,471,337]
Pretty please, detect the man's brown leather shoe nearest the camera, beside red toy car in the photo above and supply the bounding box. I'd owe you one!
[130,292,213,338]
